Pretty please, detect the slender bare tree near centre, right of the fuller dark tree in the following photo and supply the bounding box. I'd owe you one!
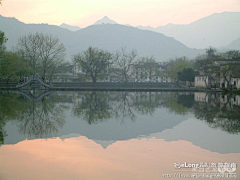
[113,48,137,83]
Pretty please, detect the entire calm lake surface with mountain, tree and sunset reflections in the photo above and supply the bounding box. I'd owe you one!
[0,91,240,180]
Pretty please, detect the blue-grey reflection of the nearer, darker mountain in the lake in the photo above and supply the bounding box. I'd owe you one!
[5,106,186,146]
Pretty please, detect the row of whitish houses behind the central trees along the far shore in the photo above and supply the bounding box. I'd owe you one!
[53,62,172,83]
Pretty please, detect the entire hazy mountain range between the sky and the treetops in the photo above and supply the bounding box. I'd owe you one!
[0,12,240,62]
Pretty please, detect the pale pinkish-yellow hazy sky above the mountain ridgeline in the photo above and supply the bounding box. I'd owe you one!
[0,0,240,27]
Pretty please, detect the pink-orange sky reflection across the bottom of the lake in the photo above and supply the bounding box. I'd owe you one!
[0,136,240,180]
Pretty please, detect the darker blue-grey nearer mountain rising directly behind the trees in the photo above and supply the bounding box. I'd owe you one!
[0,16,203,62]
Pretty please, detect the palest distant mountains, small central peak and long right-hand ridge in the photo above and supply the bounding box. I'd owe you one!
[57,12,240,49]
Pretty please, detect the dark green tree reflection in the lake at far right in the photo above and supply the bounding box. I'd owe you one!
[193,94,240,133]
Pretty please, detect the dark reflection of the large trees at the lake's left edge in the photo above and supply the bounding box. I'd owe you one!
[0,92,64,143]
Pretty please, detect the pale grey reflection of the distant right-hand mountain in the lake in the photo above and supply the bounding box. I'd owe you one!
[152,118,240,154]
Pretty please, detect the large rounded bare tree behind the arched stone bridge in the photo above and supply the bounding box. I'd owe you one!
[18,33,66,79]
